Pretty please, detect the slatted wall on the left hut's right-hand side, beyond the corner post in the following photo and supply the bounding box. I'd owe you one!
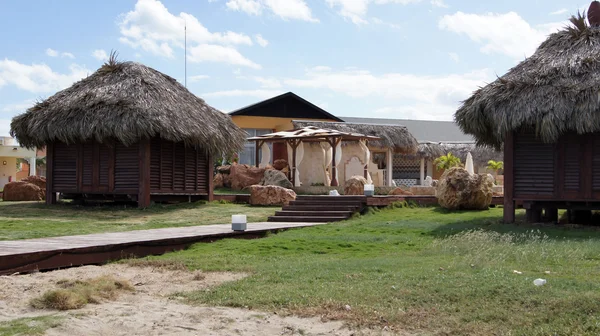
[150,139,208,194]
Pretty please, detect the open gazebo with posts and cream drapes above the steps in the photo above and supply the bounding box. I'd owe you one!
[248,126,380,187]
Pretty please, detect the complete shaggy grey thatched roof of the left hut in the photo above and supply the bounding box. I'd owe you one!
[11,57,247,155]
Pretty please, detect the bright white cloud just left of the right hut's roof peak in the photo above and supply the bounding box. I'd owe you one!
[438,12,565,59]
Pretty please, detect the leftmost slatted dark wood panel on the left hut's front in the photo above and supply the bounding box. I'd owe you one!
[52,143,77,192]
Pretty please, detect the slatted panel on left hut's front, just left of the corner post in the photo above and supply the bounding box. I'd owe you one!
[114,143,140,191]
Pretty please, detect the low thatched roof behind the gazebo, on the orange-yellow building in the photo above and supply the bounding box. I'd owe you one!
[292,120,419,153]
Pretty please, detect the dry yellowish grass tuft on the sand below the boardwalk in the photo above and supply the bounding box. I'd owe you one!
[31,276,133,310]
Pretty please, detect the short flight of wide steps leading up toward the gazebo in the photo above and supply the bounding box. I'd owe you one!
[269,195,367,223]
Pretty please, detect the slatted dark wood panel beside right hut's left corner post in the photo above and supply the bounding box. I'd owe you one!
[514,133,555,198]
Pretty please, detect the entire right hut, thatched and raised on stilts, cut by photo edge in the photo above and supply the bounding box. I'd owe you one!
[455,5,600,223]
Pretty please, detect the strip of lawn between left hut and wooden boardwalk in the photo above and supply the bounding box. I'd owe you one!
[0,202,280,240]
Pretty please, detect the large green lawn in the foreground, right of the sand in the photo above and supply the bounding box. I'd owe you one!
[136,208,600,335]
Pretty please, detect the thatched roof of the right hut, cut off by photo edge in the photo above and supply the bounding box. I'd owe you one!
[455,11,600,148]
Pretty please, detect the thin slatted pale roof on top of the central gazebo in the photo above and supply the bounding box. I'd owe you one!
[248,126,379,142]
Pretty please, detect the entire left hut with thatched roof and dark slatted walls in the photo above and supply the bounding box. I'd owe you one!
[11,55,246,207]
